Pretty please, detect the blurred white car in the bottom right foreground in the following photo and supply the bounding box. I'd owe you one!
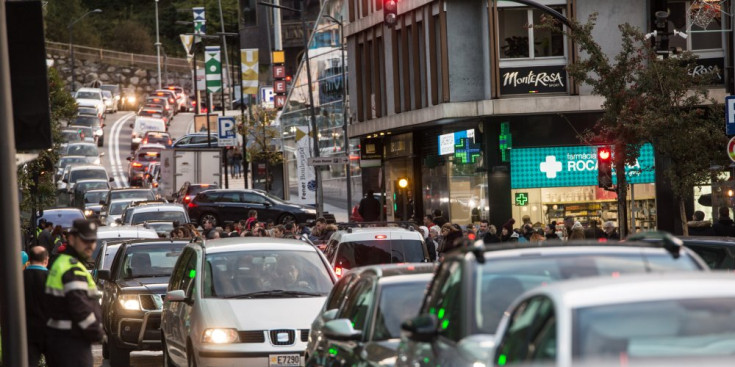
[487,273,735,367]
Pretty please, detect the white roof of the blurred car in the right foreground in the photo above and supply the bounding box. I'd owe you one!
[522,272,735,309]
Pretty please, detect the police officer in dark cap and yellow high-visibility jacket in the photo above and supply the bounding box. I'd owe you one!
[46,219,105,367]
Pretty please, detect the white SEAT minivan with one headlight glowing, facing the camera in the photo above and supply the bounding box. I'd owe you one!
[161,237,336,366]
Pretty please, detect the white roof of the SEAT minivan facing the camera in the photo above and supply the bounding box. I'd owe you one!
[197,237,318,254]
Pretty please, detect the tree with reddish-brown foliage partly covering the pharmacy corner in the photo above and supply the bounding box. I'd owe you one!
[541,14,727,236]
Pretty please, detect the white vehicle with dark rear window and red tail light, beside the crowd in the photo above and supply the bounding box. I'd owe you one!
[324,227,429,276]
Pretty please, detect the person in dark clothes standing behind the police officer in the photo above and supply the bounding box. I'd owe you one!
[23,246,49,367]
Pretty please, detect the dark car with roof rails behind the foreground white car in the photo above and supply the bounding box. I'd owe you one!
[396,241,709,366]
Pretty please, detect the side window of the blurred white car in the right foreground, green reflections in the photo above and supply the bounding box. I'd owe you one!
[497,296,556,366]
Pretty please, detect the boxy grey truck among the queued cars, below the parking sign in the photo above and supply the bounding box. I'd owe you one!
[158,148,223,199]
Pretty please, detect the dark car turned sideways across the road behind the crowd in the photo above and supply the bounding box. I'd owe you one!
[187,190,316,225]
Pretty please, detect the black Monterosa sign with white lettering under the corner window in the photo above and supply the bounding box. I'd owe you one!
[500,65,567,94]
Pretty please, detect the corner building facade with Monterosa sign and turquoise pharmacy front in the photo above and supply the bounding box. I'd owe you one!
[345,0,732,231]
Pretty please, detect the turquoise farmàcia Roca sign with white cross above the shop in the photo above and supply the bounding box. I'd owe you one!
[510,144,656,189]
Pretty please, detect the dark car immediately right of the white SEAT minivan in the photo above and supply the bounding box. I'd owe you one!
[304,264,435,367]
